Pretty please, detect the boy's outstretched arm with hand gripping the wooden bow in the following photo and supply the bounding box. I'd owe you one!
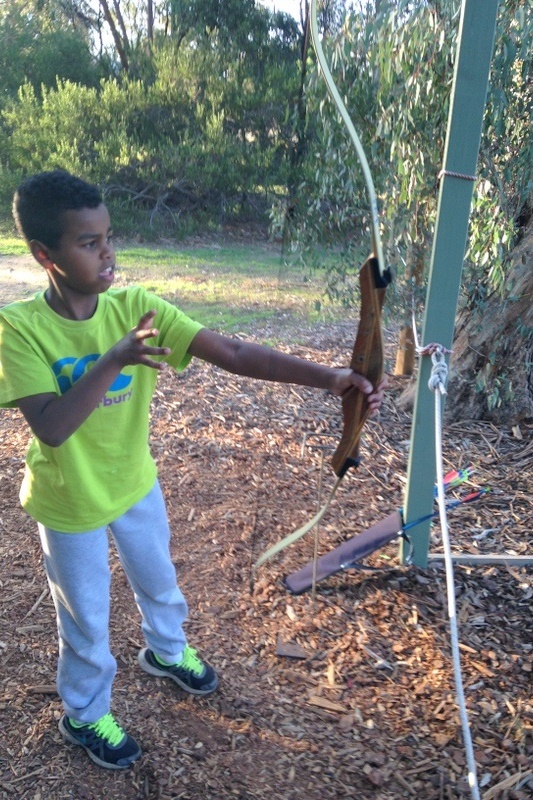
[188,328,384,410]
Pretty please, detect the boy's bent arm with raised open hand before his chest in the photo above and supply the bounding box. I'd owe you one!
[17,311,170,447]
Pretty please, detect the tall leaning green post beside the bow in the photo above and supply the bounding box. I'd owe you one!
[401,0,498,567]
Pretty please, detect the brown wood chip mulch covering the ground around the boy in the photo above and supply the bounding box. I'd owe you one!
[0,325,533,800]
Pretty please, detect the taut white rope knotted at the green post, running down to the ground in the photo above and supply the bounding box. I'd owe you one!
[428,345,480,800]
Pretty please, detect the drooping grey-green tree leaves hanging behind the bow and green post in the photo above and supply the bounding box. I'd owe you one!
[280,0,533,318]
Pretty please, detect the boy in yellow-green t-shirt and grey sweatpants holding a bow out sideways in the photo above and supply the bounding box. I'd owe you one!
[0,170,384,769]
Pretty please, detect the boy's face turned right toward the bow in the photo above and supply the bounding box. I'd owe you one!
[34,204,115,295]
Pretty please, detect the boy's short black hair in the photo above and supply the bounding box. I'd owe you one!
[13,169,102,249]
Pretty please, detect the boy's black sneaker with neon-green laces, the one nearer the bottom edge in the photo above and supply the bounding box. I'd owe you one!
[59,714,141,769]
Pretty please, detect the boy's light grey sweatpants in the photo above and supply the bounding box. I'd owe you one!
[39,482,187,723]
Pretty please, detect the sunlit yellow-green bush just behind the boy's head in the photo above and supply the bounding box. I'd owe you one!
[2,69,282,234]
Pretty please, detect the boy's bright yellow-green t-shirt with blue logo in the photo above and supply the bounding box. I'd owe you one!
[0,287,202,532]
